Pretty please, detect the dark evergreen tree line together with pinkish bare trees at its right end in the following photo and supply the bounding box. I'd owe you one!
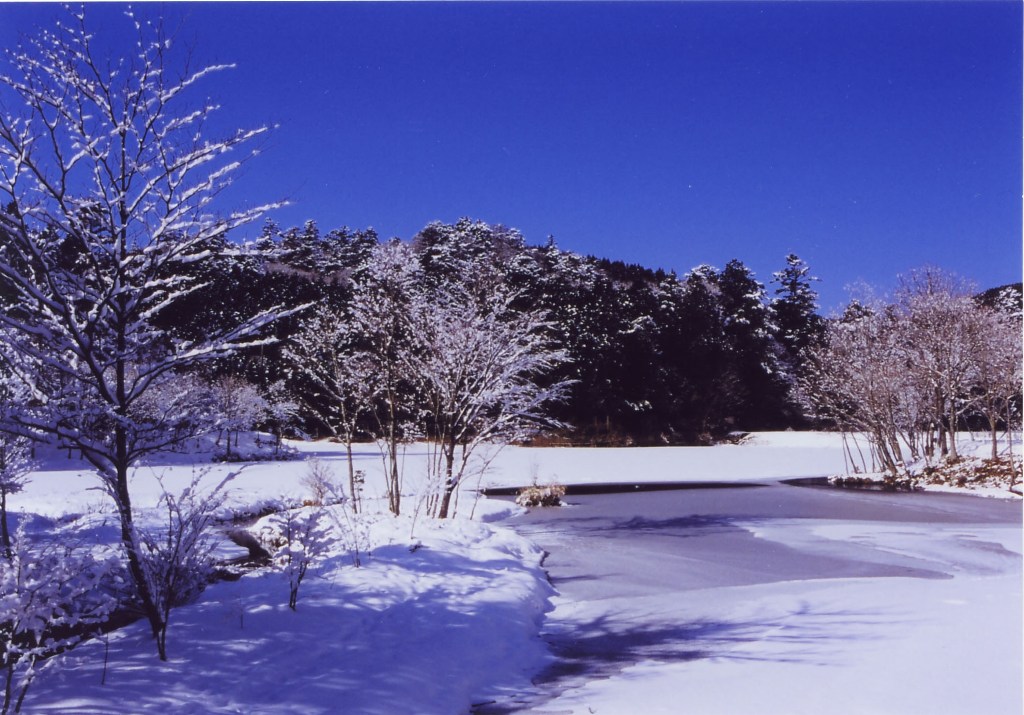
[182,218,1021,458]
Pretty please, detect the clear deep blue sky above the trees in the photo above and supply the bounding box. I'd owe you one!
[0,0,1024,311]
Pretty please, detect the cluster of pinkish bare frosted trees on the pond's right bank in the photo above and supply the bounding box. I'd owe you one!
[803,268,1021,476]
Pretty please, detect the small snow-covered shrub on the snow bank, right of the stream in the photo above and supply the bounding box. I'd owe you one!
[258,507,333,611]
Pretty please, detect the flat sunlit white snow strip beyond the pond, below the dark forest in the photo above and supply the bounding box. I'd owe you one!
[14,432,1020,521]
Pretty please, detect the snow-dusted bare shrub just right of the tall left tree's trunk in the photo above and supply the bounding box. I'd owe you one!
[138,474,233,660]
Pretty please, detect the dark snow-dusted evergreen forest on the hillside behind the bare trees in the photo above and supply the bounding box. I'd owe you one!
[153,218,824,445]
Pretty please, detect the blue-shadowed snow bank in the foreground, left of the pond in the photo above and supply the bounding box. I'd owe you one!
[22,503,551,715]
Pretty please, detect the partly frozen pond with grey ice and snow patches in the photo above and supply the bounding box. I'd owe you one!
[482,482,1021,713]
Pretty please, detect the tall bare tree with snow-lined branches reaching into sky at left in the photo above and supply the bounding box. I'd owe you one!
[0,11,290,655]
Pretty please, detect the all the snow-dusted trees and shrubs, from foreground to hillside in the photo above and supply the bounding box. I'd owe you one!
[0,9,1021,712]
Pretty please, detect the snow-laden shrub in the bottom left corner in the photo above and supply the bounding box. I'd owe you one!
[0,525,117,715]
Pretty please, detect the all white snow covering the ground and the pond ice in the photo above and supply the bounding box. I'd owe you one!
[10,433,1022,715]
